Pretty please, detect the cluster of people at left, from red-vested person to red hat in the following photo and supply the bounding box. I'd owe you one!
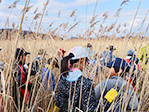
[12,48,66,109]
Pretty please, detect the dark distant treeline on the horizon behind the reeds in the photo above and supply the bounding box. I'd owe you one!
[0,29,145,40]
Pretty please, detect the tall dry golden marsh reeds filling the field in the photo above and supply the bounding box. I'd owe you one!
[0,0,149,112]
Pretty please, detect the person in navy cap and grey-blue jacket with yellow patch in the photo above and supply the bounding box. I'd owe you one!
[95,58,138,112]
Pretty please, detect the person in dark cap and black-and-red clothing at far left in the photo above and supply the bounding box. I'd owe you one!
[13,48,33,109]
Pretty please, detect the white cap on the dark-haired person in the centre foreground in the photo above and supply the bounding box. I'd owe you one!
[69,46,89,60]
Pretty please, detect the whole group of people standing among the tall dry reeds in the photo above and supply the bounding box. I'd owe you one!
[0,43,149,112]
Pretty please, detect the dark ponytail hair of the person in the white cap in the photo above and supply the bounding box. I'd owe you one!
[61,53,75,76]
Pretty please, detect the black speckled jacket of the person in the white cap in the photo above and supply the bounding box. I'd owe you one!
[55,76,96,112]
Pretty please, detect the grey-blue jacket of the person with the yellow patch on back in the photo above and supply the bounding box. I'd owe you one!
[95,76,138,111]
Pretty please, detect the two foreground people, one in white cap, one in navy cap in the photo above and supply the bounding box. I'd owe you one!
[55,46,141,112]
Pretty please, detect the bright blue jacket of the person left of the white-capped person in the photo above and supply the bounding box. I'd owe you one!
[41,67,55,91]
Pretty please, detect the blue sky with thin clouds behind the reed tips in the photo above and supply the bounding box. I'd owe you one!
[0,0,149,36]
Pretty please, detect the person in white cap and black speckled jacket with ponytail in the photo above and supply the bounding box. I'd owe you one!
[55,46,96,112]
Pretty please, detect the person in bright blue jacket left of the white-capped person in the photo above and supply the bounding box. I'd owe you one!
[41,58,59,111]
